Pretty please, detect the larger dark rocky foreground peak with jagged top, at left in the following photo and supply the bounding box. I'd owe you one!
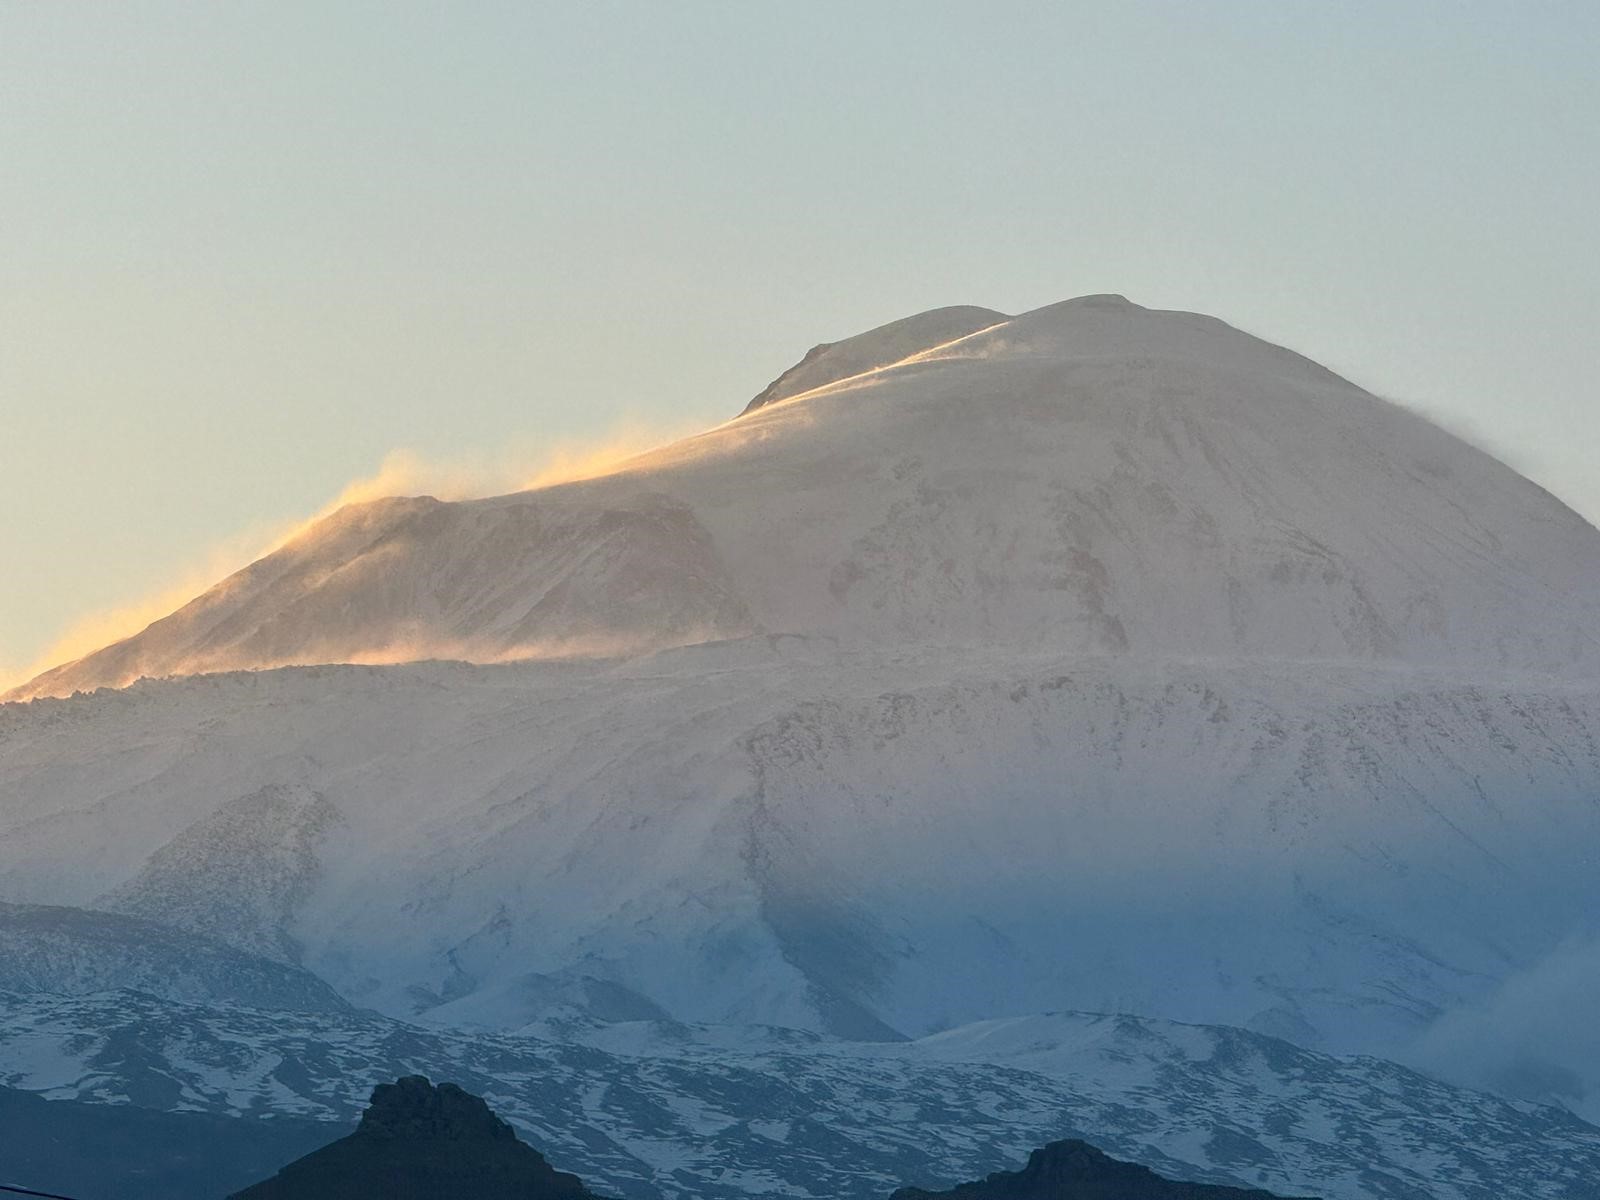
[229,1075,611,1200]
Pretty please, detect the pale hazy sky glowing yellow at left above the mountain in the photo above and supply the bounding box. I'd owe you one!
[0,0,1600,675]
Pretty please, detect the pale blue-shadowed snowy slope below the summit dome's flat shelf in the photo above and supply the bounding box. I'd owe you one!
[0,652,1600,1104]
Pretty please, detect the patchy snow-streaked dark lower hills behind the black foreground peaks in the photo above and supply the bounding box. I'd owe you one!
[0,992,1600,1200]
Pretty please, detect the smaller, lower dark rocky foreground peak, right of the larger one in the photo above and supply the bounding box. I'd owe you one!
[890,1141,1309,1200]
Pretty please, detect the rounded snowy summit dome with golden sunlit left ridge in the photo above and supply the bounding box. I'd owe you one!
[11,296,1600,699]
